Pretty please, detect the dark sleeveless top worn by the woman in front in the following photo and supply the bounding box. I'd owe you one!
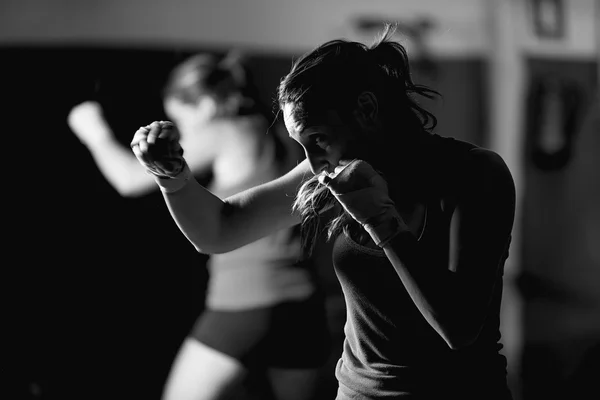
[333,135,510,400]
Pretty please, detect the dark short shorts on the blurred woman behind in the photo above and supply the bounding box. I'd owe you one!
[189,295,331,368]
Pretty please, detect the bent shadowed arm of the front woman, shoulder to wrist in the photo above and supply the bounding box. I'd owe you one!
[384,150,515,349]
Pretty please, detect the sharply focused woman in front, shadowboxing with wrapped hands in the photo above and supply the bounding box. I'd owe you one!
[132,26,515,400]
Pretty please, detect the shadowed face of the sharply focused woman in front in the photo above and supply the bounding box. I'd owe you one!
[282,103,364,175]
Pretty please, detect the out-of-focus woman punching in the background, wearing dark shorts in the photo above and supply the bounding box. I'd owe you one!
[68,53,329,400]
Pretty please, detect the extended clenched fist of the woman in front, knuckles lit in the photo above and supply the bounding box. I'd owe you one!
[131,121,186,178]
